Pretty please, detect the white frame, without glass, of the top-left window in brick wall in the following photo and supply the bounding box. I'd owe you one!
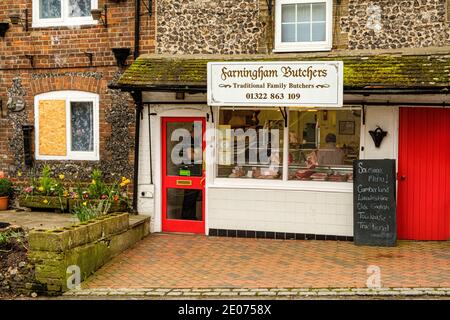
[32,0,98,28]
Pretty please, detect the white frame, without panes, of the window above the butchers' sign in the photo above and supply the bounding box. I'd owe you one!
[273,0,333,52]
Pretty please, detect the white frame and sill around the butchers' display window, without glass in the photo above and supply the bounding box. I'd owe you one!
[211,107,364,193]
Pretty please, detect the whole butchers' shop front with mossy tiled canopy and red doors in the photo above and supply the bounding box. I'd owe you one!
[113,56,450,240]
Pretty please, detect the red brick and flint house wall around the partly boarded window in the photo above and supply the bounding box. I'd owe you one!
[0,0,155,179]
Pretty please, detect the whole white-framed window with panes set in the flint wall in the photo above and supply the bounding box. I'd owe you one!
[275,0,332,52]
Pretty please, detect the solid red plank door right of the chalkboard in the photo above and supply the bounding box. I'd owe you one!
[397,108,450,240]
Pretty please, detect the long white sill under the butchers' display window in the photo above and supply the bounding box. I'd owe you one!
[206,178,353,193]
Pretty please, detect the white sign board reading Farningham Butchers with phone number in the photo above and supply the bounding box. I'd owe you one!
[208,61,344,108]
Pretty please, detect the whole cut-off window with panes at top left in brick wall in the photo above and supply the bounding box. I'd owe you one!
[33,0,98,27]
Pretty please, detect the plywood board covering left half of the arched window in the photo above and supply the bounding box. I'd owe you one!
[39,100,67,156]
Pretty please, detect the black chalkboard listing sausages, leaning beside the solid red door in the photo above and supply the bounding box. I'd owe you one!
[353,159,397,247]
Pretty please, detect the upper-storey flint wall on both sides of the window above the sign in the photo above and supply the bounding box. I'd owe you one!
[156,0,450,54]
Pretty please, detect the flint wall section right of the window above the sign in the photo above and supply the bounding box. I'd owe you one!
[341,0,450,49]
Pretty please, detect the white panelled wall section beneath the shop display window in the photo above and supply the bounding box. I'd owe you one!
[208,186,353,236]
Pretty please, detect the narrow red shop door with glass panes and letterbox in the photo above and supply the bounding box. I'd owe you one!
[162,118,205,234]
